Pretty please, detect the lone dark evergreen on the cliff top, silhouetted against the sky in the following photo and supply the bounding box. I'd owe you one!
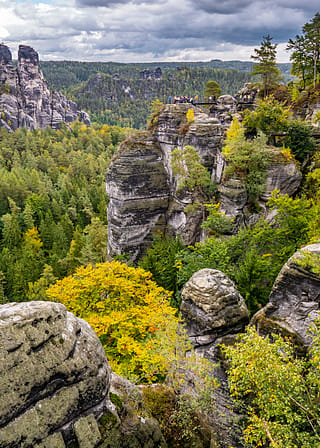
[251,34,281,97]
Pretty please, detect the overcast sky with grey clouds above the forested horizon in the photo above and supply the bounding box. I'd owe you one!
[0,0,320,62]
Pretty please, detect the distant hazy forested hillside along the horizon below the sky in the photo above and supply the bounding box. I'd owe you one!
[41,60,290,129]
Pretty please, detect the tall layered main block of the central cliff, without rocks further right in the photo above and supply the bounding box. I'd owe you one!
[106,104,222,260]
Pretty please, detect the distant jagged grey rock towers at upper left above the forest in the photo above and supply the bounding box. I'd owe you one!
[0,44,90,131]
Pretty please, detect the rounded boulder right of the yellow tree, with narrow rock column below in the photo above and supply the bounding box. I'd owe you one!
[180,269,249,448]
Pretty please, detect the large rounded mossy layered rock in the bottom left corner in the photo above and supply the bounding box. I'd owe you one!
[0,302,111,448]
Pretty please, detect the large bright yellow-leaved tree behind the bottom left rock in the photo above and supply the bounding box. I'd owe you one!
[46,261,182,382]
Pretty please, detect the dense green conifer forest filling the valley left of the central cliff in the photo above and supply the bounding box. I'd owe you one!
[0,123,127,303]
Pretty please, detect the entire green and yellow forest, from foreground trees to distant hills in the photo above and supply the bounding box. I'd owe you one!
[0,10,320,448]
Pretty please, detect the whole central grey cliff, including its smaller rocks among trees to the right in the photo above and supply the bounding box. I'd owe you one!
[106,101,302,260]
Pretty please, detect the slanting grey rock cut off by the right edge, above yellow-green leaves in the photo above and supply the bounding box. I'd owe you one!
[252,243,320,347]
